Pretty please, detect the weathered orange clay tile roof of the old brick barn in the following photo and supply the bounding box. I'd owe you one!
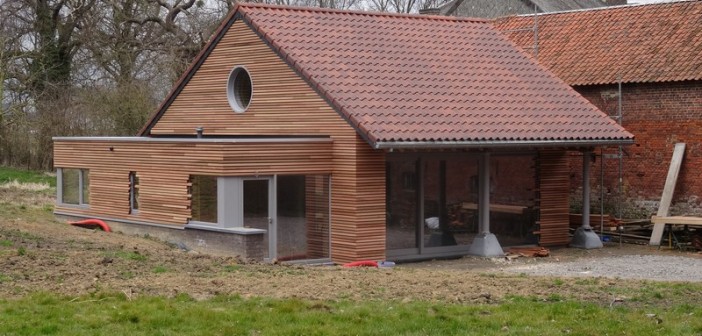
[494,1,702,86]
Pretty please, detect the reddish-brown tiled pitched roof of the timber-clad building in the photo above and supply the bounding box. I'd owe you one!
[143,4,633,148]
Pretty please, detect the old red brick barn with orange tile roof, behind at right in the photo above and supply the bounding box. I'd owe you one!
[495,1,702,218]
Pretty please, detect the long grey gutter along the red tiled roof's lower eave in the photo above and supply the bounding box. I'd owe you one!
[374,139,634,150]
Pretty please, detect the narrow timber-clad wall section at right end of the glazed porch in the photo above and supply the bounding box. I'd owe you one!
[537,150,570,246]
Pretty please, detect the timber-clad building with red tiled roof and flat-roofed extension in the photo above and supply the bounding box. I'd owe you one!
[54,4,633,262]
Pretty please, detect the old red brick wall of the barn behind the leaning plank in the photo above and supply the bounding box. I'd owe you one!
[571,81,702,217]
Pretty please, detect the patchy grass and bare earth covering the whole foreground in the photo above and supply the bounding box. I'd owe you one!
[0,167,702,336]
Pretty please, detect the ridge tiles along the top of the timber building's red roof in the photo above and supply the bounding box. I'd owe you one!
[237,2,491,23]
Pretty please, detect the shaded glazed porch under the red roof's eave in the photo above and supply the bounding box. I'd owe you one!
[386,149,596,260]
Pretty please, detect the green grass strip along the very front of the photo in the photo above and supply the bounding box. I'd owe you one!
[0,293,702,335]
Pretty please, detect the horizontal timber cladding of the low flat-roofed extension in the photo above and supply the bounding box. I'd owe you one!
[54,139,332,226]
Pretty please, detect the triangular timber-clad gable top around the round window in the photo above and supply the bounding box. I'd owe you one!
[151,20,353,136]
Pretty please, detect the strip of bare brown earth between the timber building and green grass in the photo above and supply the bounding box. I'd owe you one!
[0,188,702,304]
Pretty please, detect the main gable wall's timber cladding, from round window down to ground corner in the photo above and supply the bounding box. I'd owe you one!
[151,21,385,262]
